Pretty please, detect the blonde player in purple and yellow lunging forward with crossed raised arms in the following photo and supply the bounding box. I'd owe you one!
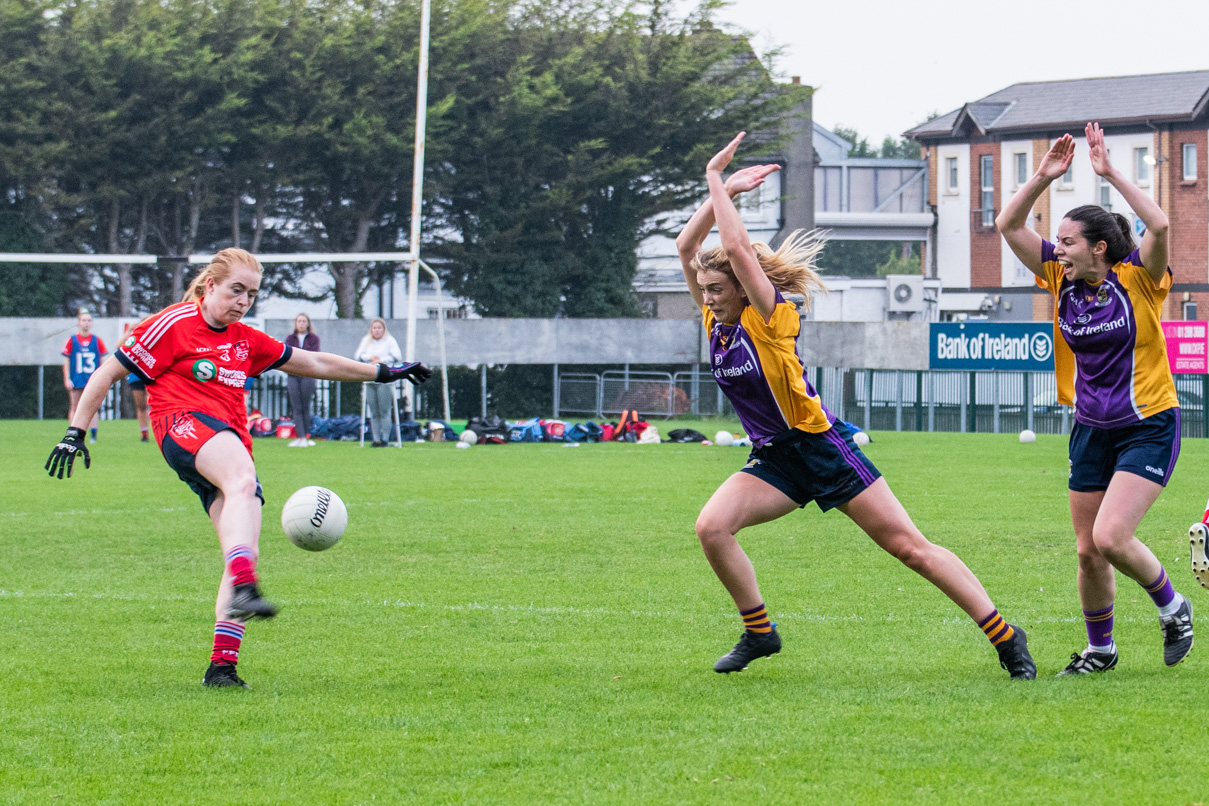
[676,133,1036,679]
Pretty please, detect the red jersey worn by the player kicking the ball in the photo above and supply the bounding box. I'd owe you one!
[116,302,291,453]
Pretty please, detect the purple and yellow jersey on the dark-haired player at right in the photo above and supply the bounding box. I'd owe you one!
[1041,240,1180,428]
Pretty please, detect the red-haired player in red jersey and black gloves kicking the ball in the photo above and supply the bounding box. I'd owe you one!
[46,249,432,688]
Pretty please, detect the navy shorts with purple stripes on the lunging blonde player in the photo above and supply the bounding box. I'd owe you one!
[742,421,881,512]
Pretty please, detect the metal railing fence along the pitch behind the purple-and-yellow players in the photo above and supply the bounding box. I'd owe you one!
[554,367,1209,437]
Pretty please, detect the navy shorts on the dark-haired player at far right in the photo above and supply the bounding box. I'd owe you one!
[1069,408,1180,493]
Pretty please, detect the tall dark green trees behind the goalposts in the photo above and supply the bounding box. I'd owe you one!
[0,0,810,317]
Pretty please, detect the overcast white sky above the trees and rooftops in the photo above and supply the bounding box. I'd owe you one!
[706,0,1209,147]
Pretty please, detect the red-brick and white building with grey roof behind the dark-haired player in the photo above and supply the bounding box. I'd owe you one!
[906,70,1209,320]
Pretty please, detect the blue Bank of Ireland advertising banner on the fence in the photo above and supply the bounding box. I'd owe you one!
[927,321,1054,372]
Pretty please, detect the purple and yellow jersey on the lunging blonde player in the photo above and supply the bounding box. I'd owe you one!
[701,291,835,447]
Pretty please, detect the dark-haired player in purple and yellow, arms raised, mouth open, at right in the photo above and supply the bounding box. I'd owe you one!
[995,123,1193,674]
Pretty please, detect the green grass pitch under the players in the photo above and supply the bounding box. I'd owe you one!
[0,422,1209,804]
